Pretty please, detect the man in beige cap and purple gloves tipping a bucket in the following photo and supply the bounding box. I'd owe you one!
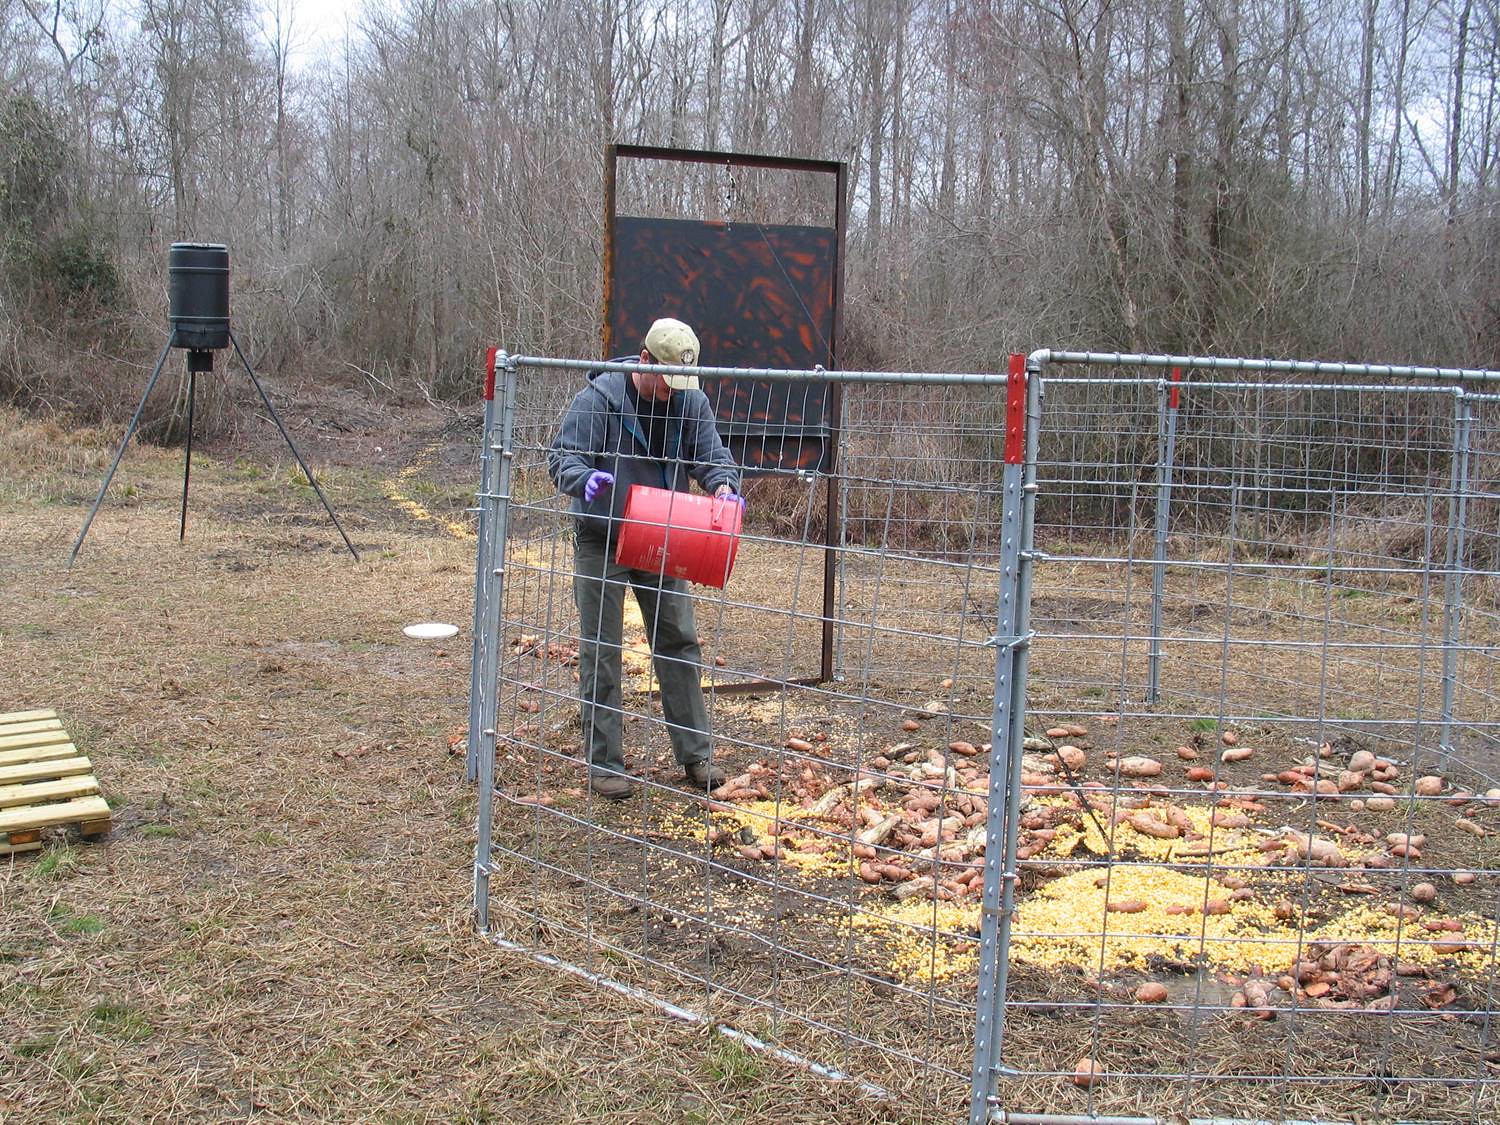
[548,318,744,801]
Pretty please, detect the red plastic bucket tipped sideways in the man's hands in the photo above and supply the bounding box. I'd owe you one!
[615,485,744,590]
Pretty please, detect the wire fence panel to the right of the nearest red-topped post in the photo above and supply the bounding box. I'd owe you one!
[996,357,1500,1122]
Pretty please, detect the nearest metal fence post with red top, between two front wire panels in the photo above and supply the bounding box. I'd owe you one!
[969,356,1041,1125]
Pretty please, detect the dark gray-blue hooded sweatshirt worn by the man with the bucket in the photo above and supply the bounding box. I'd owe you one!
[548,366,740,539]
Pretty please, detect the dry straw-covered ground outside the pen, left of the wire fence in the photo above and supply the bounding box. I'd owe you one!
[0,404,912,1125]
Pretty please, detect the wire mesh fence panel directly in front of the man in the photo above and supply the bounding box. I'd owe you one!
[480,354,1026,1119]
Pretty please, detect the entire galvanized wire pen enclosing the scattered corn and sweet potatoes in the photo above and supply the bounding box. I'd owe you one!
[471,348,1500,1125]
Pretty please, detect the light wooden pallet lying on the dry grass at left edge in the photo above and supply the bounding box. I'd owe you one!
[0,711,110,855]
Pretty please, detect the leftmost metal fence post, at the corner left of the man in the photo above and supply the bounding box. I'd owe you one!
[474,353,516,933]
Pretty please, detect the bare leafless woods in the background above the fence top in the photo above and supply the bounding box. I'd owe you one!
[0,0,1500,420]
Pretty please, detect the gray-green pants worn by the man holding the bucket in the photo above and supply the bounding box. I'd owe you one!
[573,536,708,774]
